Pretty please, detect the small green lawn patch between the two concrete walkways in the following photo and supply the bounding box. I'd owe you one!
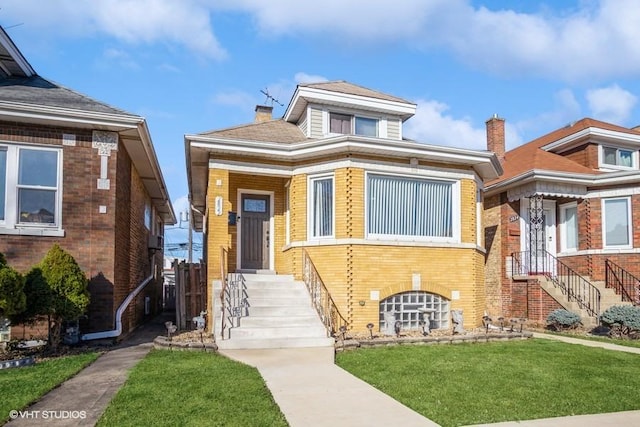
[98,350,287,427]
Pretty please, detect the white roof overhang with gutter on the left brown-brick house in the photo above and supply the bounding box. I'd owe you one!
[0,101,176,224]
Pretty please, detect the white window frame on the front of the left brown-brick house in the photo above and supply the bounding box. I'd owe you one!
[0,141,64,236]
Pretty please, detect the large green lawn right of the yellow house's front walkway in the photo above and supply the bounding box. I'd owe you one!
[337,339,640,426]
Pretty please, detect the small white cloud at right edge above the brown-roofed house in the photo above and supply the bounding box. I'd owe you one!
[586,84,638,125]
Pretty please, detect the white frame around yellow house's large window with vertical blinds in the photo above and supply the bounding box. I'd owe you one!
[364,171,462,243]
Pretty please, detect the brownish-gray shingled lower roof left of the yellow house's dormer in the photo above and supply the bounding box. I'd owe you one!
[199,119,308,144]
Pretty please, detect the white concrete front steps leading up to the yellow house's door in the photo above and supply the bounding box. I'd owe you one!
[216,273,335,350]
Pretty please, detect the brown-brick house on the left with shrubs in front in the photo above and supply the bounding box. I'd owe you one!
[0,28,176,339]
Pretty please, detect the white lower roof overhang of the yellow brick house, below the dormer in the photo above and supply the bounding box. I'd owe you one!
[185,135,502,230]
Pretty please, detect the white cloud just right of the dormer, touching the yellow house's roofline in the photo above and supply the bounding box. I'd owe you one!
[404,100,486,150]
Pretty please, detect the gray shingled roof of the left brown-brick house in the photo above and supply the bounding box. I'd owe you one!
[0,75,135,116]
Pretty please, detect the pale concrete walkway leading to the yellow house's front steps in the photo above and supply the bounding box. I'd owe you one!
[220,347,438,427]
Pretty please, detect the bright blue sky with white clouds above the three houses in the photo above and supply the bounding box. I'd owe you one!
[0,0,640,258]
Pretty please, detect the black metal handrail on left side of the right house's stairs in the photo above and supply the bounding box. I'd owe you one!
[511,250,601,317]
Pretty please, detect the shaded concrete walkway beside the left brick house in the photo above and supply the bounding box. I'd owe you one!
[6,316,167,427]
